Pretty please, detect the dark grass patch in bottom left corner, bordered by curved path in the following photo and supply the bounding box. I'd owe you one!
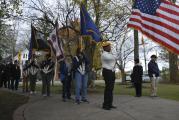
[0,90,28,120]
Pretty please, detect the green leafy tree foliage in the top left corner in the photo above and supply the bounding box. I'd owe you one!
[0,0,22,57]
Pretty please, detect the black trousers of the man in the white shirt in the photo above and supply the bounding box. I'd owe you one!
[102,68,115,108]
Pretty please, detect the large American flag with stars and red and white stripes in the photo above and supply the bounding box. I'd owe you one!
[128,0,179,54]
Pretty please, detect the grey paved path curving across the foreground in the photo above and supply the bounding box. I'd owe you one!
[14,95,179,120]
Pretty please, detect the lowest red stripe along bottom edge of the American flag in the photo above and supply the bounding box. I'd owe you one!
[128,23,179,54]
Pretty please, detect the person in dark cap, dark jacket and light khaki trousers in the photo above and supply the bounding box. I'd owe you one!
[148,55,160,97]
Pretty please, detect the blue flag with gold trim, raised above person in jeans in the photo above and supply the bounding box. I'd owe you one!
[80,5,102,42]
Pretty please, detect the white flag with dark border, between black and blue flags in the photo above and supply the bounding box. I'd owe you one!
[48,21,64,61]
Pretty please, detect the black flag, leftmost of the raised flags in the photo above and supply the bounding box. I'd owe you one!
[28,25,50,59]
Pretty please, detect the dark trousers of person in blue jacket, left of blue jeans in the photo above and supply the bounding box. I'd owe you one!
[62,76,71,99]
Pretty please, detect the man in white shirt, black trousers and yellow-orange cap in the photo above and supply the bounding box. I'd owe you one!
[101,42,116,110]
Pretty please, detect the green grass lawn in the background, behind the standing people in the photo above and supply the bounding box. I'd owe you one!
[34,83,179,101]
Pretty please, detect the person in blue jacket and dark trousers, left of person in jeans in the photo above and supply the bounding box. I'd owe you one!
[60,56,72,102]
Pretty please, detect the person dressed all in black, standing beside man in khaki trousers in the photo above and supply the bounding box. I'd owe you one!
[131,58,143,97]
